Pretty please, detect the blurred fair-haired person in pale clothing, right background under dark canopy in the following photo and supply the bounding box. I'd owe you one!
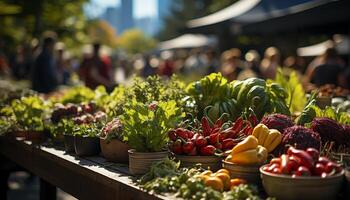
[260,47,281,79]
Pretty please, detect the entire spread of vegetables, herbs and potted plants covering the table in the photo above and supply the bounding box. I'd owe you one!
[0,70,350,200]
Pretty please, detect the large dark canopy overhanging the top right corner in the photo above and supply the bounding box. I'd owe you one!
[239,0,350,34]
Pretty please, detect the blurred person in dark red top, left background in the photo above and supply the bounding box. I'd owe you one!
[79,43,114,89]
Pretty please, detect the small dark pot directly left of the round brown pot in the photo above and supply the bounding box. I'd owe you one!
[74,136,100,156]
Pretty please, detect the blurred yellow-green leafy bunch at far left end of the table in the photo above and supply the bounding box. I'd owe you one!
[11,96,47,131]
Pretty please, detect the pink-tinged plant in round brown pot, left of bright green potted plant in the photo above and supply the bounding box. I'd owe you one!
[100,118,129,163]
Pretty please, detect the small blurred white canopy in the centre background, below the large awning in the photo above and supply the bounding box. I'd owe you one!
[158,34,217,50]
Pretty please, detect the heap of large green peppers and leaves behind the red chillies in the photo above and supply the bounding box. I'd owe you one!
[187,73,290,121]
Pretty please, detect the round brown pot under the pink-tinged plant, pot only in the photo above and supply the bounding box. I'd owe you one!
[100,138,129,163]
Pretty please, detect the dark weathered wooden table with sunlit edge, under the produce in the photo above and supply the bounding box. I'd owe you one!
[0,137,173,200]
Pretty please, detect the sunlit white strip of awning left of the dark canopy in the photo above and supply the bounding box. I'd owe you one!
[187,0,261,28]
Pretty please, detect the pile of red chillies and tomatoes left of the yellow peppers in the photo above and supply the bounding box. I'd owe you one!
[168,115,257,156]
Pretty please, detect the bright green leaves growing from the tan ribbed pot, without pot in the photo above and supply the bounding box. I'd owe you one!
[121,99,184,152]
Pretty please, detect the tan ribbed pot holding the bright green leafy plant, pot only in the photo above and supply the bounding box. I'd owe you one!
[128,149,168,175]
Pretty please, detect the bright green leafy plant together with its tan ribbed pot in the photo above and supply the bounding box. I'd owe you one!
[121,99,184,175]
